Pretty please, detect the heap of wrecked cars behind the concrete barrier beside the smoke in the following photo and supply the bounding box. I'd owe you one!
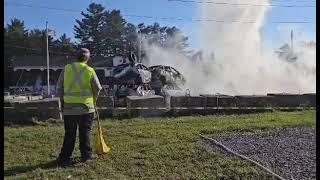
[109,53,185,97]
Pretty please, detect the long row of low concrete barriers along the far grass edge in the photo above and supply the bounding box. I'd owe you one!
[4,93,316,122]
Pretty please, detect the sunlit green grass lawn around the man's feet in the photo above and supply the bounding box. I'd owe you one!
[4,111,316,179]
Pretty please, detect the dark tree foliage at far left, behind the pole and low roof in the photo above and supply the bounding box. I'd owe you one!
[3,18,75,87]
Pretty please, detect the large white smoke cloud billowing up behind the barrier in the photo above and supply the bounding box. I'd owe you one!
[142,0,316,95]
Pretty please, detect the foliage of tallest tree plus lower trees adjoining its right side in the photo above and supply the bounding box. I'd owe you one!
[74,3,188,57]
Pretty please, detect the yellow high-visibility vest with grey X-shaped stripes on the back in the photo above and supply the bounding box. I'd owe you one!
[63,62,94,104]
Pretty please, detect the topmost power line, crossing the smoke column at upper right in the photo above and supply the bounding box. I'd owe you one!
[168,0,316,8]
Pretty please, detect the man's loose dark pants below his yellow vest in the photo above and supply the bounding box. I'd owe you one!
[59,113,94,161]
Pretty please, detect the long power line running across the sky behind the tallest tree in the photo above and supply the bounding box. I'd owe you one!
[5,2,312,24]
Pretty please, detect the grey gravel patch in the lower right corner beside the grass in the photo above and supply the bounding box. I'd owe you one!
[204,127,316,180]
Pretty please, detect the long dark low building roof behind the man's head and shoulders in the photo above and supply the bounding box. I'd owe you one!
[12,55,113,68]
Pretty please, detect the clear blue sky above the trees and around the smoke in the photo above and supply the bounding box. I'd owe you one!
[4,0,316,49]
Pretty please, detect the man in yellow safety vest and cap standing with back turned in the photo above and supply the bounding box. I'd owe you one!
[57,48,102,164]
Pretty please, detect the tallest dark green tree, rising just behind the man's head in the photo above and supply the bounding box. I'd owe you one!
[74,3,137,57]
